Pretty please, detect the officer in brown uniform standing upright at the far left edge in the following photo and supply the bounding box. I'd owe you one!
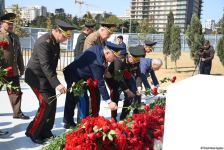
[0,13,29,119]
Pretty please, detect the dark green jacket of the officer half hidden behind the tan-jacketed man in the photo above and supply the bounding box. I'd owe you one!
[74,32,87,57]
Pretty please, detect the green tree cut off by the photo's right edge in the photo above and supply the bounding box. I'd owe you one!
[217,14,224,66]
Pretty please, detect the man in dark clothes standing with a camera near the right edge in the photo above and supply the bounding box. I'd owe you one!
[199,40,215,75]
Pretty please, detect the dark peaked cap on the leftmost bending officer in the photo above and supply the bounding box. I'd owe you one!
[55,19,75,38]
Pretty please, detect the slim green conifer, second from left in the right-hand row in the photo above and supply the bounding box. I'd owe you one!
[170,24,181,72]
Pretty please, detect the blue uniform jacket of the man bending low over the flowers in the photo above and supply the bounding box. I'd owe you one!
[63,45,110,100]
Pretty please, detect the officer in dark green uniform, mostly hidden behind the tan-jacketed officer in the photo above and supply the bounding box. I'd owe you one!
[74,23,95,57]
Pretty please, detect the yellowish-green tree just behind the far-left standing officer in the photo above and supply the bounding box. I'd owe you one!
[12,4,29,37]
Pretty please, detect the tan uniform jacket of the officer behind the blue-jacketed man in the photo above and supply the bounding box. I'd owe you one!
[83,31,106,51]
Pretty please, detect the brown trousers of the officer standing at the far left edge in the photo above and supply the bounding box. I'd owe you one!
[0,76,22,117]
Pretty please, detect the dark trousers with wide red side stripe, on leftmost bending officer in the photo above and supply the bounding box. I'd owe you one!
[26,88,57,138]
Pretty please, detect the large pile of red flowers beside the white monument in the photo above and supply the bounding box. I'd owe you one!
[43,99,165,150]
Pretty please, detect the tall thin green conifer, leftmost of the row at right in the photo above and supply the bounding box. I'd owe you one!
[163,11,174,69]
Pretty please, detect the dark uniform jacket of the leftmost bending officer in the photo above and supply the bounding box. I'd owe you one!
[25,33,60,91]
